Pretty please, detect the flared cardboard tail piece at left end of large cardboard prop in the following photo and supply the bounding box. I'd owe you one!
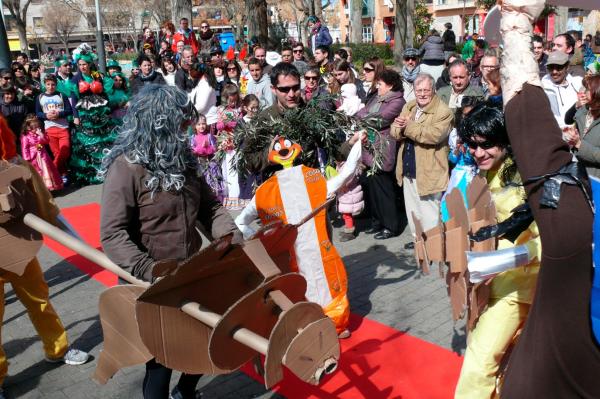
[93,285,153,384]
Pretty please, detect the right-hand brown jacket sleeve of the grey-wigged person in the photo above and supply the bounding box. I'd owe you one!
[198,177,243,243]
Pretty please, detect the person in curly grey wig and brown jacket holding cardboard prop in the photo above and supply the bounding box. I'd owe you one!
[100,85,241,399]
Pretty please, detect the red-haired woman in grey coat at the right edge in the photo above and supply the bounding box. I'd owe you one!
[566,75,600,178]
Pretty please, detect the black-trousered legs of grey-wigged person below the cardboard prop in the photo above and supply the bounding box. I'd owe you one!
[142,359,202,399]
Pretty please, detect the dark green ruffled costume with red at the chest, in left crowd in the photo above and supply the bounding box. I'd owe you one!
[70,72,116,185]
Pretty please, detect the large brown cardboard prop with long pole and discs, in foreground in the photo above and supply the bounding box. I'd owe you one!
[24,202,340,388]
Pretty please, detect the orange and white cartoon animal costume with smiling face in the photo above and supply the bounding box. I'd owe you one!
[236,137,361,334]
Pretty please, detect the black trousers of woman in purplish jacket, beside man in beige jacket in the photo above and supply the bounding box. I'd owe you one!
[366,172,400,234]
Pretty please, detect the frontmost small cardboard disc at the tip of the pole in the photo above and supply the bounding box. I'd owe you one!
[283,317,340,385]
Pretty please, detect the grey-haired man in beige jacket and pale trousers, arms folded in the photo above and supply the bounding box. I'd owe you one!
[390,74,453,249]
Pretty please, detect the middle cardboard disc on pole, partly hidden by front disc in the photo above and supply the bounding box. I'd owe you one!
[264,302,325,389]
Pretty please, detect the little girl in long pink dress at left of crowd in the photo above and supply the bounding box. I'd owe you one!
[21,115,63,191]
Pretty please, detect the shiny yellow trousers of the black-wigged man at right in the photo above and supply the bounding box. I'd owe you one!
[454,298,535,399]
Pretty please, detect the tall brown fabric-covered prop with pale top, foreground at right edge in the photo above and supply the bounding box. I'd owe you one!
[500,0,600,399]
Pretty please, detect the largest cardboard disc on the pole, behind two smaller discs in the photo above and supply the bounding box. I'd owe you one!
[209,273,306,370]
